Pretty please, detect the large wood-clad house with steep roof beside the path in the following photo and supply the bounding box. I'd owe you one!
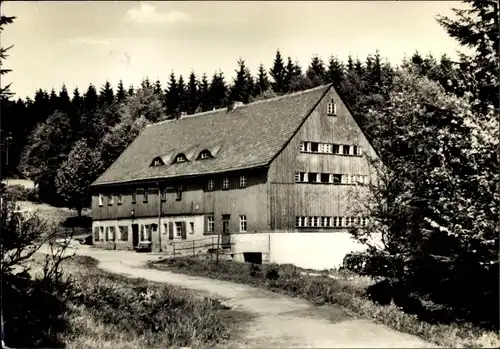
[92,85,376,270]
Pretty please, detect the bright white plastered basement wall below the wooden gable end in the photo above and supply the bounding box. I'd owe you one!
[231,231,380,270]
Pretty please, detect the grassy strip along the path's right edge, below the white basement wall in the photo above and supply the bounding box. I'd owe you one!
[149,257,500,348]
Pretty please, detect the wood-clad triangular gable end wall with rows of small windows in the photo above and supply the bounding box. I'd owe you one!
[268,85,376,230]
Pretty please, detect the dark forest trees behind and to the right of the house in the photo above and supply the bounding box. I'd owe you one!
[1,0,500,340]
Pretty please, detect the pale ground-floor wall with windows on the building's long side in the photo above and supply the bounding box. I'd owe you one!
[92,215,205,252]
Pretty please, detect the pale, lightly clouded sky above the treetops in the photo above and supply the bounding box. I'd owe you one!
[1,1,462,98]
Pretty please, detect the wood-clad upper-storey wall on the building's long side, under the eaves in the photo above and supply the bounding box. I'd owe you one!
[92,169,268,234]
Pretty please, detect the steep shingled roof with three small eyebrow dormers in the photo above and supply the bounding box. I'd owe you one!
[92,85,331,186]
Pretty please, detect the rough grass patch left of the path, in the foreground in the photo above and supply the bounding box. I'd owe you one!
[20,256,249,349]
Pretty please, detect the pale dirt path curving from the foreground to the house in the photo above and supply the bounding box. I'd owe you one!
[43,243,436,348]
